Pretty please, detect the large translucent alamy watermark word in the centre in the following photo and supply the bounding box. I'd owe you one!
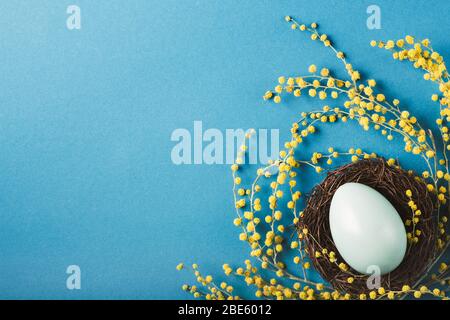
[170,121,280,165]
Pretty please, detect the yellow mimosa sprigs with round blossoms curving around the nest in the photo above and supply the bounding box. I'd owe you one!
[177,16,450,300]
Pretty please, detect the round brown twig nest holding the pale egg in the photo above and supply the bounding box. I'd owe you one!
[298,158,436,294]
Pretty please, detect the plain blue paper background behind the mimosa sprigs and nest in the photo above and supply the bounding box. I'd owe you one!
[0,0,450,299]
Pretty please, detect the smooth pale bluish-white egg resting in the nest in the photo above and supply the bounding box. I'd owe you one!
[330,183,407,274]
